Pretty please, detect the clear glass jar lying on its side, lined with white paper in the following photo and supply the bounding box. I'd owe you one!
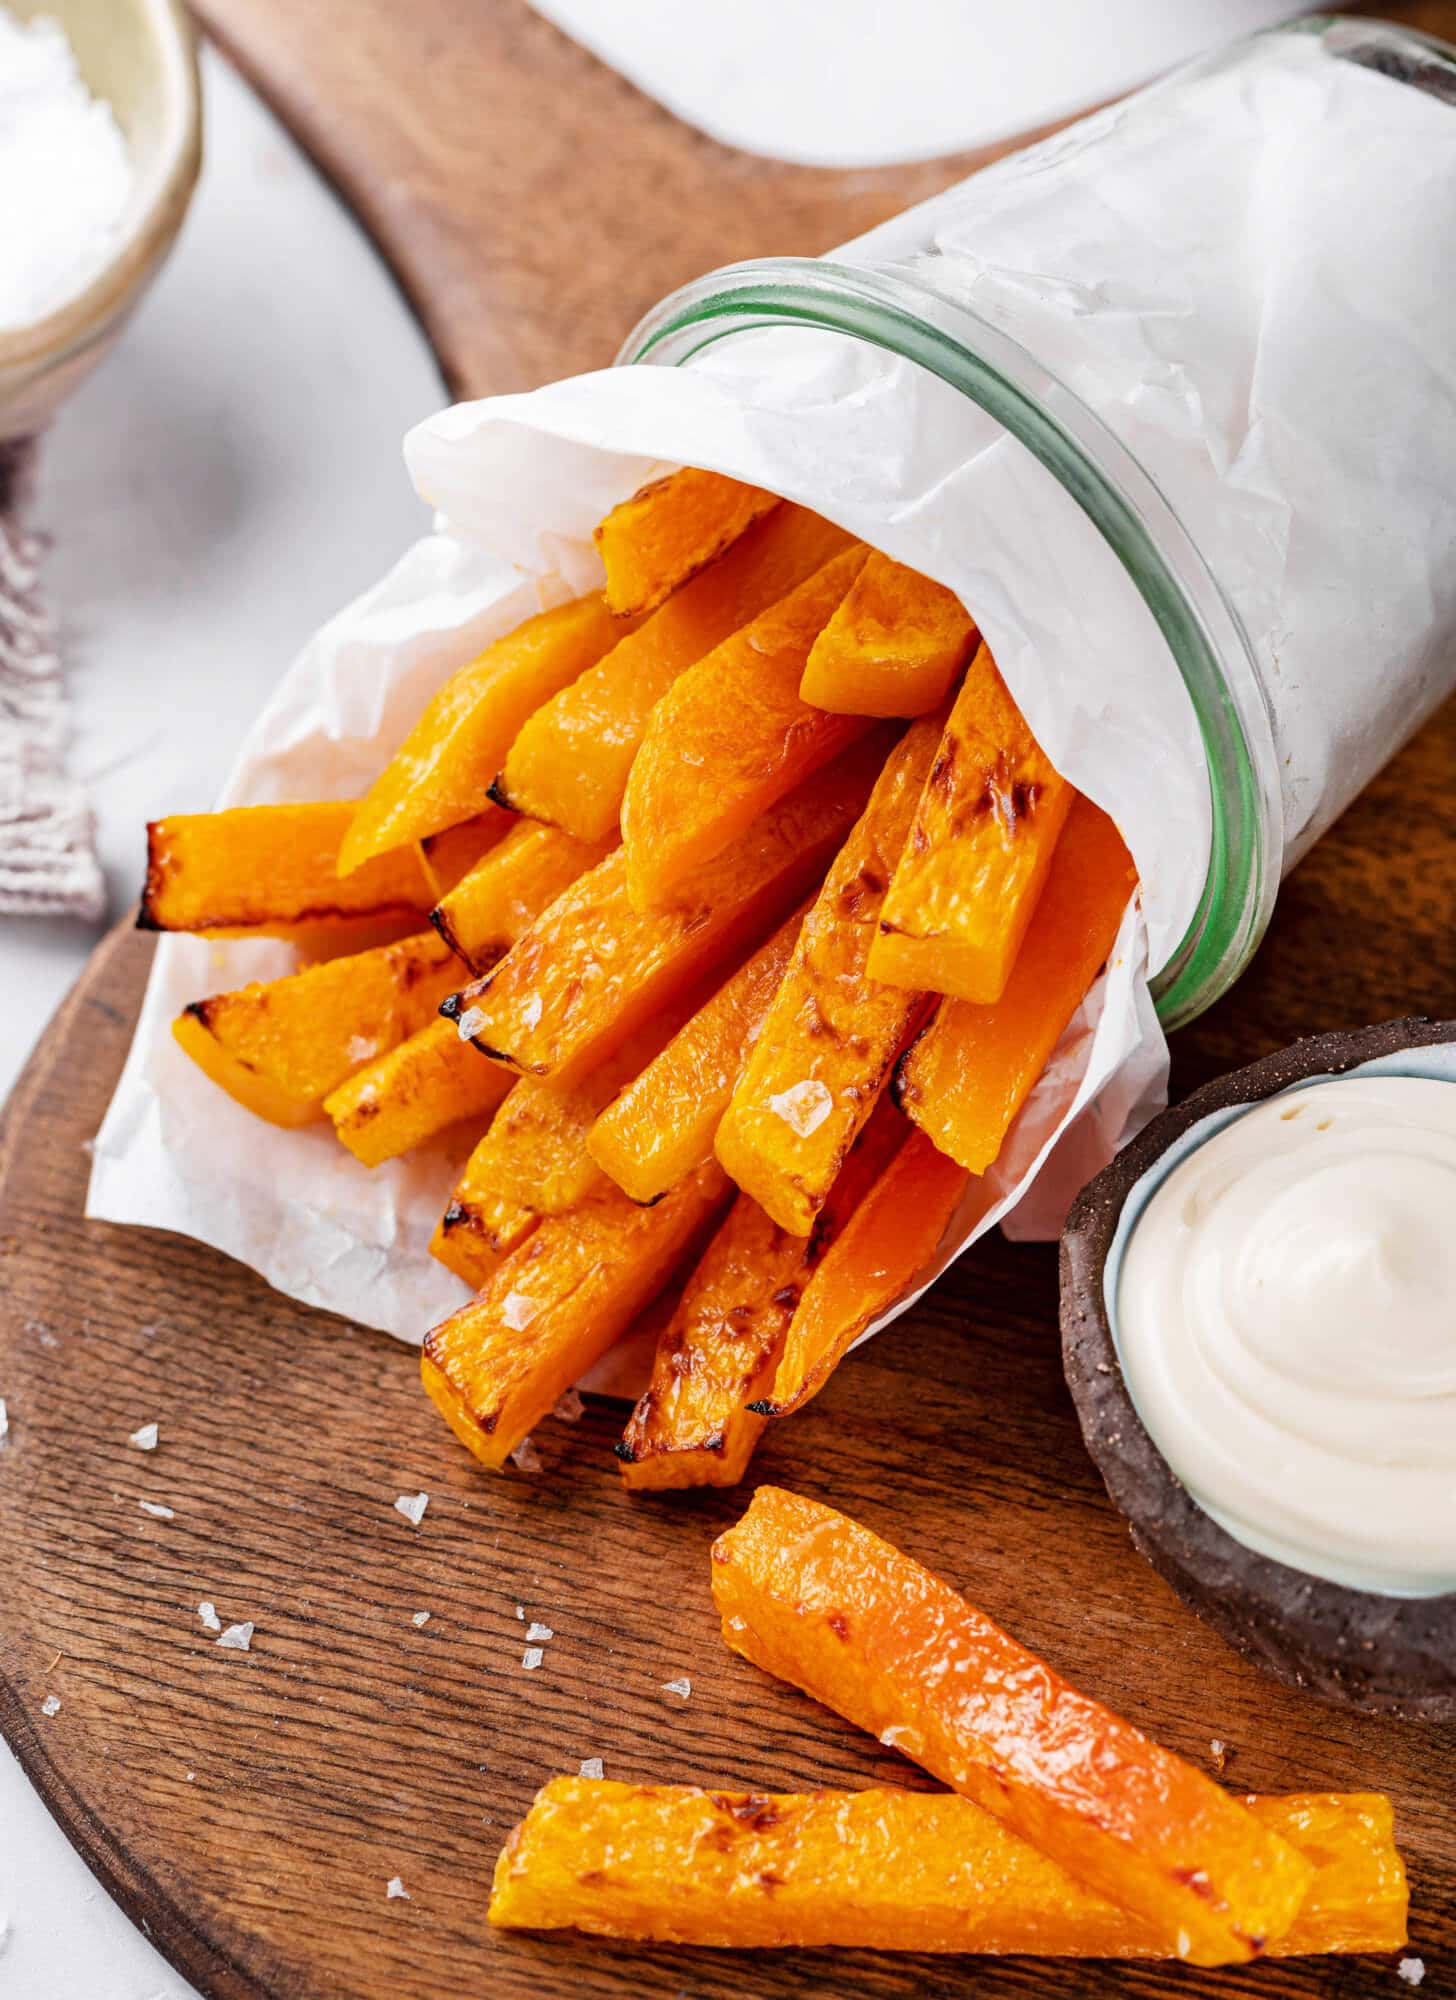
[620,16,1456,1026]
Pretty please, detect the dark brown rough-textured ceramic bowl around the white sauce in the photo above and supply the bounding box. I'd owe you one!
[1062,1020,1456,1722]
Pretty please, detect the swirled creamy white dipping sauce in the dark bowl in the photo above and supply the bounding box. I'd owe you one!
[1114,1076,1456,1596]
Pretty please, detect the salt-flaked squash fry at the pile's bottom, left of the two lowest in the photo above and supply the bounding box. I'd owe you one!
[420,1164,728,1468]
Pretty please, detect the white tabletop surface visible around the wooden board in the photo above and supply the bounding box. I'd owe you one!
[0,0,1290,2000]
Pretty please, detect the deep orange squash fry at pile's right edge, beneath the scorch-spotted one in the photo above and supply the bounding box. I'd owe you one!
[894,798,1138,1174]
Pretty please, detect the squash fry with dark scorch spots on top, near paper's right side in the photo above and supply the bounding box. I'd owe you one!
[870,646,1076,1004]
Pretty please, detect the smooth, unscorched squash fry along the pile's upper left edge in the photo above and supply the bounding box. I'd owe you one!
[338,598,622,874]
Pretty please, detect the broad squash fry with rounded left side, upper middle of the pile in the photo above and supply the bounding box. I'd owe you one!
[622,542,870,910]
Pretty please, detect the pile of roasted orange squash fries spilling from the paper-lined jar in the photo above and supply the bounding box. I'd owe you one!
[140,468,1136,1488]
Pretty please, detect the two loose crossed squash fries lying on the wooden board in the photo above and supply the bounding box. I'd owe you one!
[490,1486,1408,1960]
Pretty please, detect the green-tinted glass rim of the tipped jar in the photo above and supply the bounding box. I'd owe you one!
[618,258,1284,1028]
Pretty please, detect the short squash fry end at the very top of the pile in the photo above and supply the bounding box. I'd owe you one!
[596,466,778,618]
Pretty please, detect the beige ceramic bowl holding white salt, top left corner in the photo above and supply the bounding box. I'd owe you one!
[0,0,202,442]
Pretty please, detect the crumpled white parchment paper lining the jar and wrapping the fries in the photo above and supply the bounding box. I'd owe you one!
[88,36,1456,1376]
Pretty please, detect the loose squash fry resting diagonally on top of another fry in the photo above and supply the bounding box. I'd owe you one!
[712,1486,1314,1966]
